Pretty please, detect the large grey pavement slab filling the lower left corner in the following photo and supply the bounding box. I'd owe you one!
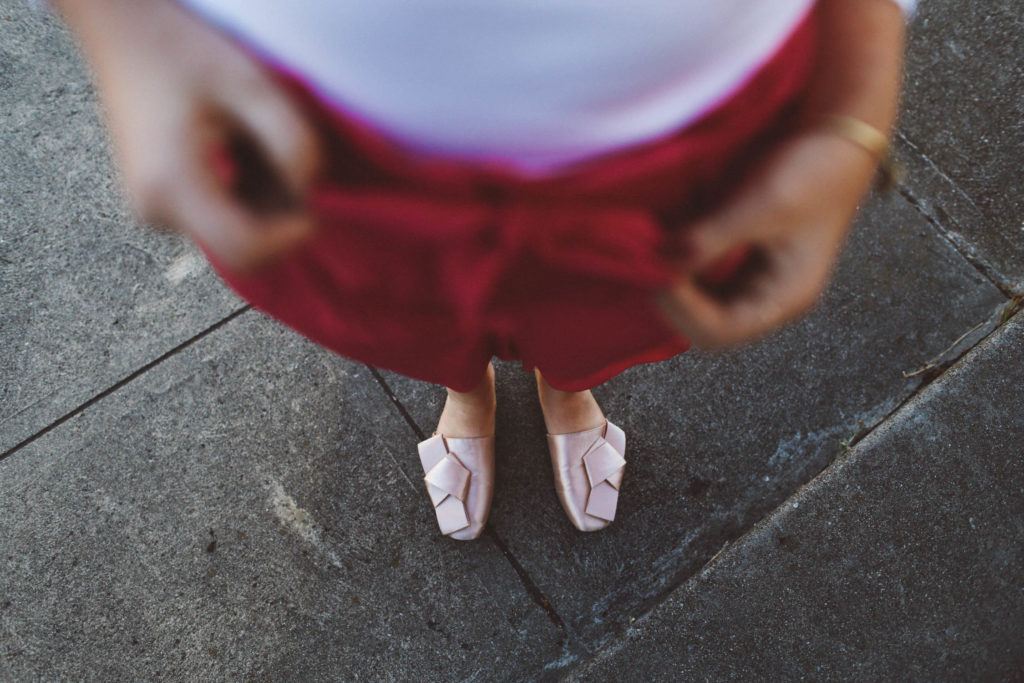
[0,312,563,681]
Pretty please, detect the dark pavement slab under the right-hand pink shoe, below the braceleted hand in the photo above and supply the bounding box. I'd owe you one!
[384,192,1005,665]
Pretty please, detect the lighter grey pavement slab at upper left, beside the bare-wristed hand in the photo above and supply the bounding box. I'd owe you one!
[0,5,242,453]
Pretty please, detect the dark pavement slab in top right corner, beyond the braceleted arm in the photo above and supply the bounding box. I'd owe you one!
[898,0,1024,293]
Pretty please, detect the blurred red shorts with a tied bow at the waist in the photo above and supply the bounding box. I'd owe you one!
[207,6,816,391]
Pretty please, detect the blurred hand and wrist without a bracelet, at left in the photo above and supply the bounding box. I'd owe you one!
[51,0,318,272]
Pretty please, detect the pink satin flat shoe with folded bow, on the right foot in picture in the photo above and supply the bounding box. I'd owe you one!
[548,420,626,531]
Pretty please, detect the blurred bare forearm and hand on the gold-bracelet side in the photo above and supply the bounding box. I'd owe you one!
[658,0,904,348]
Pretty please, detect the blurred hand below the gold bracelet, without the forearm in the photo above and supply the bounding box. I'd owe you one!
[658,129,876,349]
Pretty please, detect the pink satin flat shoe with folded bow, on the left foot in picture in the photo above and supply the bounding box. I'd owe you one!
[419,432,495,541]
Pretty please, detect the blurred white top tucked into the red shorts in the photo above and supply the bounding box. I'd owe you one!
[179,0,914,174]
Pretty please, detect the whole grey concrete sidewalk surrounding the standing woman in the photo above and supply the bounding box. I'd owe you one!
[0,0,1024,681]
